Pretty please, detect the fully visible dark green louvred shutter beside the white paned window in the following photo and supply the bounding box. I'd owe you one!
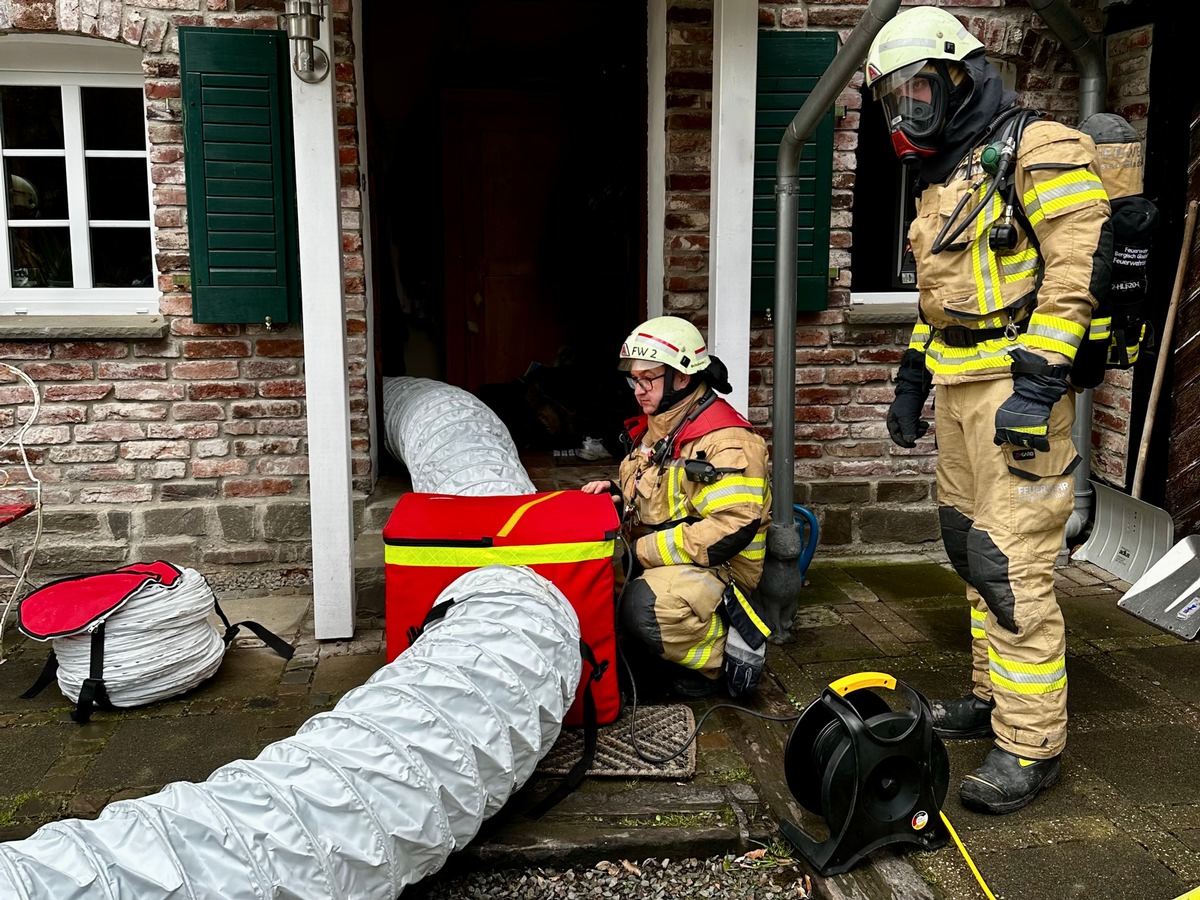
[179,28,300,325]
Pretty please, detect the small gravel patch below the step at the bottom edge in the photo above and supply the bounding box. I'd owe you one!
[402,850,812,900]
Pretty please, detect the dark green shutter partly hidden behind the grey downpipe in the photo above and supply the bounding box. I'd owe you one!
[750,31,838,312]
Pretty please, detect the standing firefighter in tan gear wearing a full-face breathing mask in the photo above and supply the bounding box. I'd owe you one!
[866,6,1111,814]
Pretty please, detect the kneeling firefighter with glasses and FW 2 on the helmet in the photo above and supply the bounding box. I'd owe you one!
[583,316,770,697]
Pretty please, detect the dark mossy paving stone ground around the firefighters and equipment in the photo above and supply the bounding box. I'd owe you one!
[0,547,1200,900]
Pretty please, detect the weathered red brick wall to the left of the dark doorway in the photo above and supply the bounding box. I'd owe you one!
[0,0,371,588]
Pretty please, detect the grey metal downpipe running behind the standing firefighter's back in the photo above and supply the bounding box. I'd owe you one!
[1030,0,1108,547]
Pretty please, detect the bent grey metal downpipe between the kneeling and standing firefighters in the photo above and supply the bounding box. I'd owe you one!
[758,0,900,643]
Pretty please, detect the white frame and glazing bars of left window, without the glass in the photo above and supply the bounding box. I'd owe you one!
[0,35,161,322]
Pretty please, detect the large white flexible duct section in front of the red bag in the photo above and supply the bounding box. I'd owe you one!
[0,565,582,900]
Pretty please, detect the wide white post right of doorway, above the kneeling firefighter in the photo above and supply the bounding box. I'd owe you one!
[708,0,758,415]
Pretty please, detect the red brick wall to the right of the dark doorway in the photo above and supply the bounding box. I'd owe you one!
[664,0,1108,552]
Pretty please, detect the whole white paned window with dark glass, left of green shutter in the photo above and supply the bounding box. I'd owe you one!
[0,37,158,318]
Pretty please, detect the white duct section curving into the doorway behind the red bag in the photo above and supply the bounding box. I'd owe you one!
[383,376,538,497]
